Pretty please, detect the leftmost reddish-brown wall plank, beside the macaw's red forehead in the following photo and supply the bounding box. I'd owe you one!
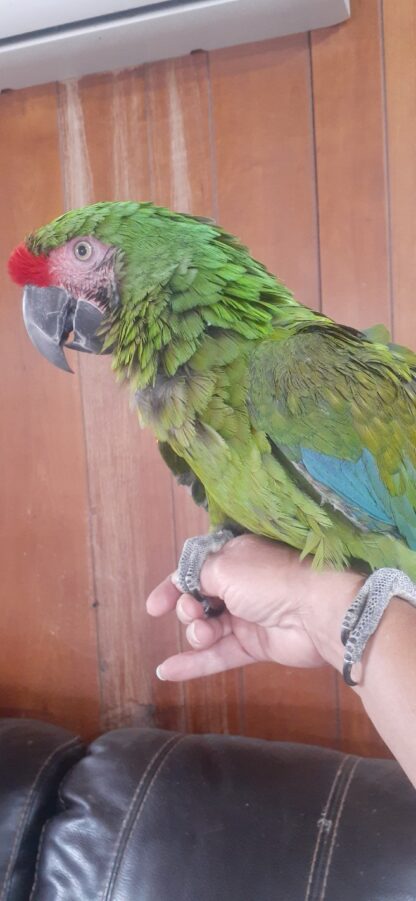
[0,87,98,736]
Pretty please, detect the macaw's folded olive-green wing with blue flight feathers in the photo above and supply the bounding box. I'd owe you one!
[249,321,416,572]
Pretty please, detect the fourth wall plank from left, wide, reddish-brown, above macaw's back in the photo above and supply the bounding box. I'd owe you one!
[210,35,337,744]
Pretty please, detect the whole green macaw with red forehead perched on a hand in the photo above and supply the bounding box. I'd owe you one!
[9,202,416,681]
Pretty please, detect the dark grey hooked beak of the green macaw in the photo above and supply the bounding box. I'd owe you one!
[23,285,111,372]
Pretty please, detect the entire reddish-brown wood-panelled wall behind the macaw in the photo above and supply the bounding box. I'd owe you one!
[0,0,416,753]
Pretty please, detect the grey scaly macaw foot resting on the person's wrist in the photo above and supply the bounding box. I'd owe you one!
[341,567,416,685]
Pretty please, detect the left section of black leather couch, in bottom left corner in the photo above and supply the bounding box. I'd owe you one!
[0,719,83,901]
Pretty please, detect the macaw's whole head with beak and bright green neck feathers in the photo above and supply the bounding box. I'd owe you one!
[9,201,297,390]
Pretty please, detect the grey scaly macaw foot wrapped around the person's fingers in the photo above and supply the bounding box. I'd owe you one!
[175,529,234,617]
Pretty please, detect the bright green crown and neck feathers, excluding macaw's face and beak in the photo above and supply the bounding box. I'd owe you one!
[28,202,315,390]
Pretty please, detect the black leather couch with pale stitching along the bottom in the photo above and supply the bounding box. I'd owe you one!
[0,719,416,901]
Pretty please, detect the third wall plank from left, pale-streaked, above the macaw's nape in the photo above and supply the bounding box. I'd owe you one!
[146,53,242,733]
